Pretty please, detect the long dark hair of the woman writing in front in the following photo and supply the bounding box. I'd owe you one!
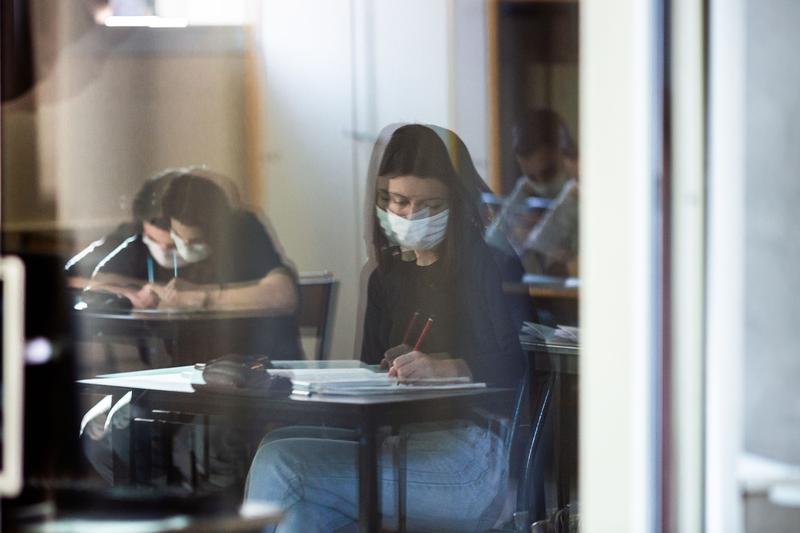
[372,124,483,274]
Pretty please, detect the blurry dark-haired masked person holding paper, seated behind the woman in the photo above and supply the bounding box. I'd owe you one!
[487,109,578,273]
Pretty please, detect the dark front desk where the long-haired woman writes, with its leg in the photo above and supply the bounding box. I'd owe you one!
[78,367,514,532]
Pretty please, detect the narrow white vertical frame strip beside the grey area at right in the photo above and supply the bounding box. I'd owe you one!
[705,0,746,533]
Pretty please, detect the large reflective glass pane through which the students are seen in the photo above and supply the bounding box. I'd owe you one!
[0,0,580,531]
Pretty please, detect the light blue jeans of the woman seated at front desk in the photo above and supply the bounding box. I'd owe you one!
[245,422,507,533]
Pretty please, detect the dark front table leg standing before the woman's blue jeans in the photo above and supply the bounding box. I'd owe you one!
[358,411,381,533]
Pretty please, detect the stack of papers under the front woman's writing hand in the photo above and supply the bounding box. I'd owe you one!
[269,368,486,396]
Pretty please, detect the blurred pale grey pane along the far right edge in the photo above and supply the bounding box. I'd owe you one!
[737,2,800,532]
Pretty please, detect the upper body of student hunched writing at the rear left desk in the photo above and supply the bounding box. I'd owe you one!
[83,172,297,312]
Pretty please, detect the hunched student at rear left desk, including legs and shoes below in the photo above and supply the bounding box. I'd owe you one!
[82,170,303,485]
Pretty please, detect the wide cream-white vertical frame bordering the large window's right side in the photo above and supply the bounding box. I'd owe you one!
[579,0,661,533]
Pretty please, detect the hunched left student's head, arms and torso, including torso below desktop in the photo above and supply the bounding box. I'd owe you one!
[73,169,302,362]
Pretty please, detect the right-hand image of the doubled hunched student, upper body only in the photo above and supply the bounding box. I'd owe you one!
[139,174,297,312]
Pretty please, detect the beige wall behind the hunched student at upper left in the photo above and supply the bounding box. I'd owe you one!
[3,19,246,248]
